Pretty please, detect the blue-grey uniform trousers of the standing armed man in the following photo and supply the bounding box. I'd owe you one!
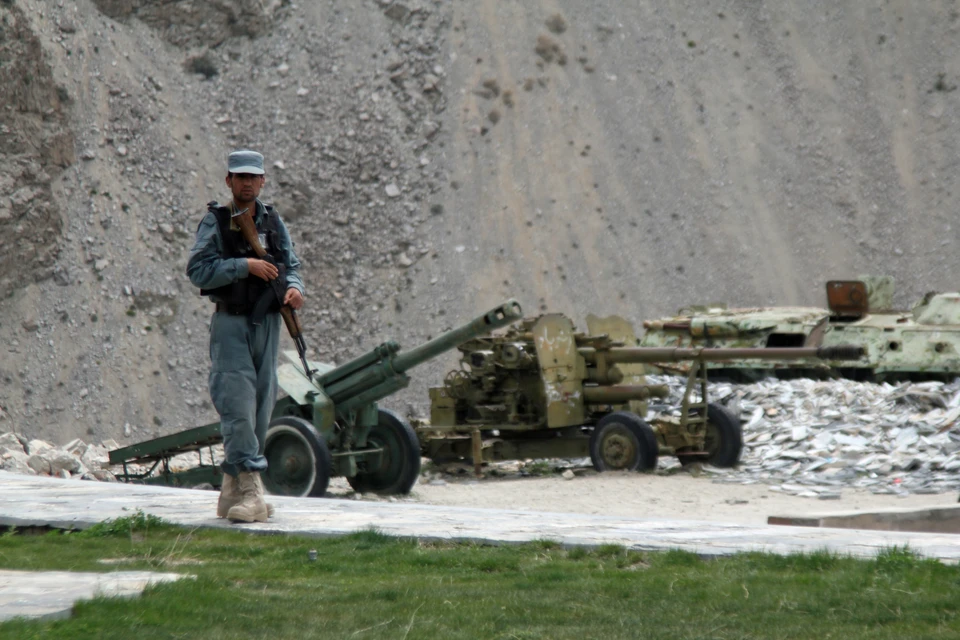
[210,312,280,477]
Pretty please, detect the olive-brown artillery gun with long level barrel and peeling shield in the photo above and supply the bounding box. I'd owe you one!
[418,314,862,473]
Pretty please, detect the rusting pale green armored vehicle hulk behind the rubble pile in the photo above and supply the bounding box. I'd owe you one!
[641,277,960,381]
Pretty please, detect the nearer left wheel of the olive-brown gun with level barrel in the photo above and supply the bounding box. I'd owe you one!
[590,411,660,471]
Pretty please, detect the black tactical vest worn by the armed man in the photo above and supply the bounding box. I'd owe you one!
[200,201,287,314]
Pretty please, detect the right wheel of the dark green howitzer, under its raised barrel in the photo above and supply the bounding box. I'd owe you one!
[347,409,420,495]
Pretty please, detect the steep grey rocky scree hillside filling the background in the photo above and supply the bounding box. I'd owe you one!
[0,0,960,443]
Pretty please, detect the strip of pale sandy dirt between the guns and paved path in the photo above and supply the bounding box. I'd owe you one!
[329,470,957,524]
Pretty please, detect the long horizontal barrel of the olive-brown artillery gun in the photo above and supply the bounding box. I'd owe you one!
[580,345,864,364]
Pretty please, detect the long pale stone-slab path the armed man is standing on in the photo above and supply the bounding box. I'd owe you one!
[0,471,960,563]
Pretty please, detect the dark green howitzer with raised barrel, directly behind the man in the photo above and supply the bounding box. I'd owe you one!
[110,300,522,497]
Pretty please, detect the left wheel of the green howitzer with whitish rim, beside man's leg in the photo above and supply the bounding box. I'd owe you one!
[263,416,333,498]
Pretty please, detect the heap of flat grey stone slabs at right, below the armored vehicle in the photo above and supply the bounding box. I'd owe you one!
[650,376,960,499]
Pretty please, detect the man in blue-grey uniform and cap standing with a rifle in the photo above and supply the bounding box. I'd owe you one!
[187,150,303,522]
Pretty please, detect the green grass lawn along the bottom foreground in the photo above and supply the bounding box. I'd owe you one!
[0,513,960,640]
